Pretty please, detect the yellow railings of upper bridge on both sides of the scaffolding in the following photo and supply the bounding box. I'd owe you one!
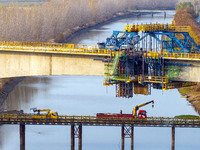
[0,41,200,61]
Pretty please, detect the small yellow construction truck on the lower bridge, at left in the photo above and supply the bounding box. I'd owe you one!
[32,108,58,119]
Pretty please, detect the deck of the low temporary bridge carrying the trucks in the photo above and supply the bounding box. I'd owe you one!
[0,114,200,128]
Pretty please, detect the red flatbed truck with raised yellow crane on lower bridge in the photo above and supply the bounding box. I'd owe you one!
[96,100,154,119]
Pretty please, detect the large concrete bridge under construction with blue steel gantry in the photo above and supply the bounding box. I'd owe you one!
[0,23,200,98]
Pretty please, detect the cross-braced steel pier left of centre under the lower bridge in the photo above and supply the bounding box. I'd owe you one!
[71,124,82,150]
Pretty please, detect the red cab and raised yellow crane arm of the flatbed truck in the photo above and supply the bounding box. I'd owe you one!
[133,100,154,118]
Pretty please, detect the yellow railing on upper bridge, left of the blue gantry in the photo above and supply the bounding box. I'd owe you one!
[0,41,111,56]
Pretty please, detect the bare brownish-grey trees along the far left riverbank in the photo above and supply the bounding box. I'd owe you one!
[0,0,176,42]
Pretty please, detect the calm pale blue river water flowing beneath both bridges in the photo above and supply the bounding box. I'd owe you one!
[0,13,200,150]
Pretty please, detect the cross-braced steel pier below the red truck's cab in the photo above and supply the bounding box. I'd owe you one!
[121,124,134,150]
